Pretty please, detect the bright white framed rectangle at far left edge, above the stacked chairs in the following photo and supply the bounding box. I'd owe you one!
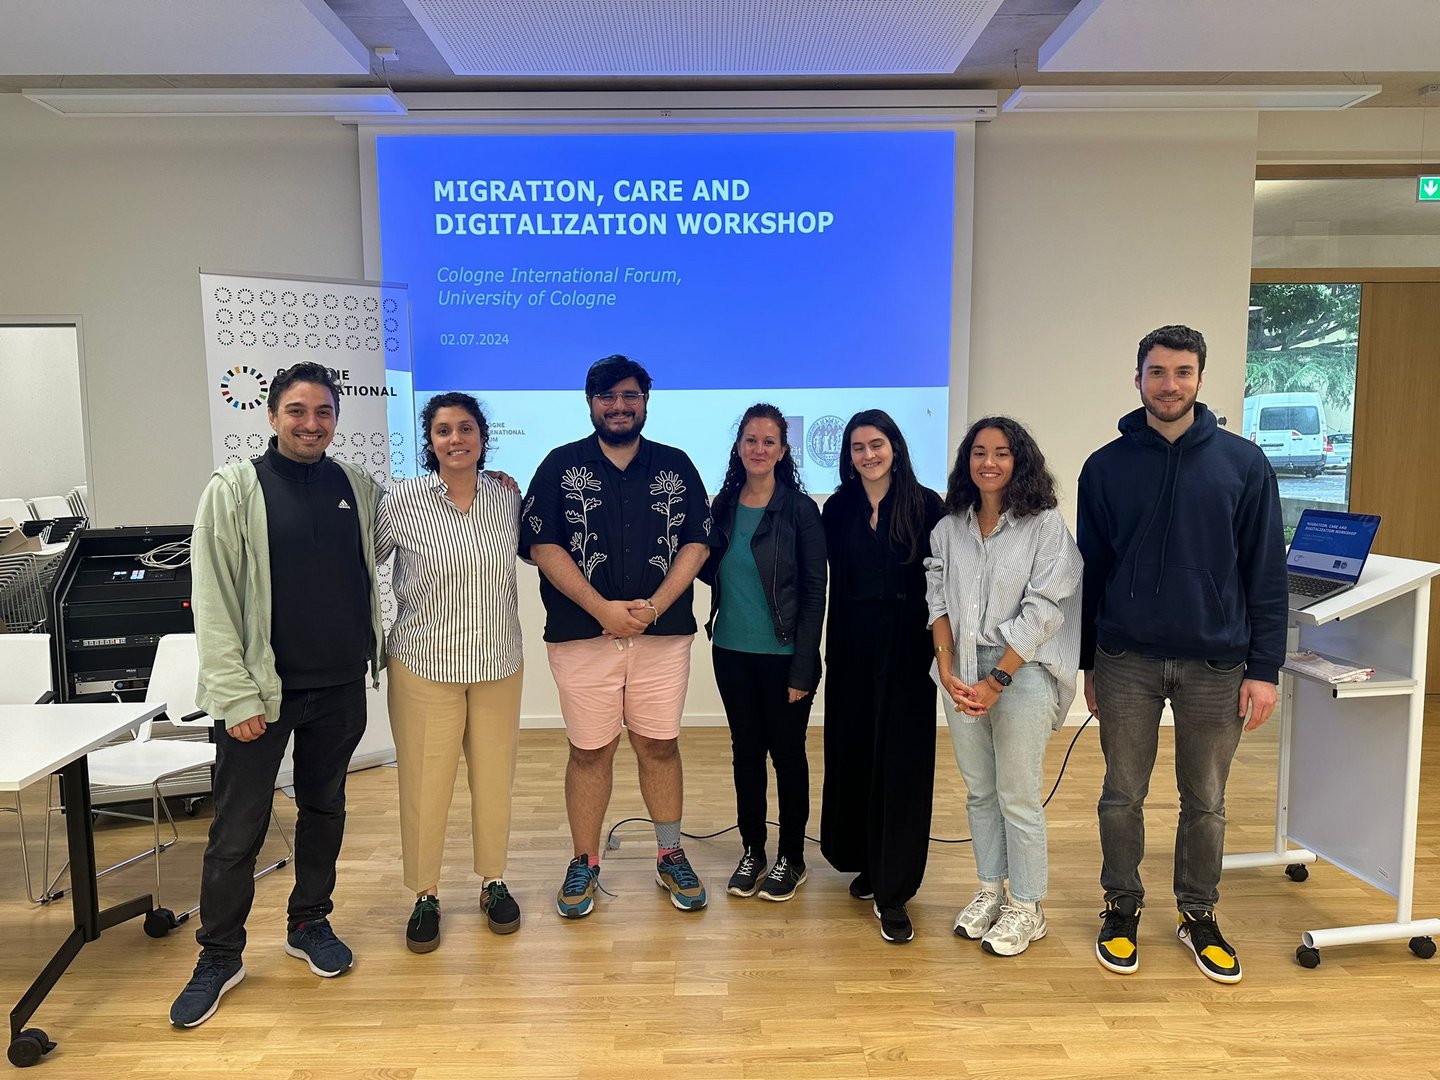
[0,320,85,498]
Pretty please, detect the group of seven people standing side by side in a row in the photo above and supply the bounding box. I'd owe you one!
[170,325,1287,1027]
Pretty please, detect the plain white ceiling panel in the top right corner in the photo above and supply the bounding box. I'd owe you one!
[1040,0,1440,74]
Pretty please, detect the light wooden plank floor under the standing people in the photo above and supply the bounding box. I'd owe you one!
[0,708,1440,1080]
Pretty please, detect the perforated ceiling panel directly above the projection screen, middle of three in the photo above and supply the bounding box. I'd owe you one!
[405,0,1001,76]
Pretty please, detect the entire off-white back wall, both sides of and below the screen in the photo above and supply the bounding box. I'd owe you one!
[0,95,1256,723]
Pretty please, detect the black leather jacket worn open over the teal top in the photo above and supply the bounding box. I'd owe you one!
[700,484,827,691]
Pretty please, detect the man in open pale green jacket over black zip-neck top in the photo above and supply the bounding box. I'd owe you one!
[170,363,384,1028]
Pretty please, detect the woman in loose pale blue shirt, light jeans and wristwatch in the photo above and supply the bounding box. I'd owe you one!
[926,416,1081,956]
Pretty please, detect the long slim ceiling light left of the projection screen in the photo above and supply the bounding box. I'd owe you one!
[20,88,405,117]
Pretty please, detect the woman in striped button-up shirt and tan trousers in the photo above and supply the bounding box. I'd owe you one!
[376,393,523,952]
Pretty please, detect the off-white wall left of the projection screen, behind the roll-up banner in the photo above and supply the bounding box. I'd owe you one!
[0,94,360,524]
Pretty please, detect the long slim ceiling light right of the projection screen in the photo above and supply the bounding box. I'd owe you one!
[1005,84,1381,112]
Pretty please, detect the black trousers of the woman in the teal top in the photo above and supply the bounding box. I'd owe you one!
[713,645,815,865]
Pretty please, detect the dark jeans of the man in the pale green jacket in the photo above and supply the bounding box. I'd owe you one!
[194,680,366,956]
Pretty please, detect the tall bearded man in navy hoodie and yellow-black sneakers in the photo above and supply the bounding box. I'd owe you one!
[1077,325,1289,982]
